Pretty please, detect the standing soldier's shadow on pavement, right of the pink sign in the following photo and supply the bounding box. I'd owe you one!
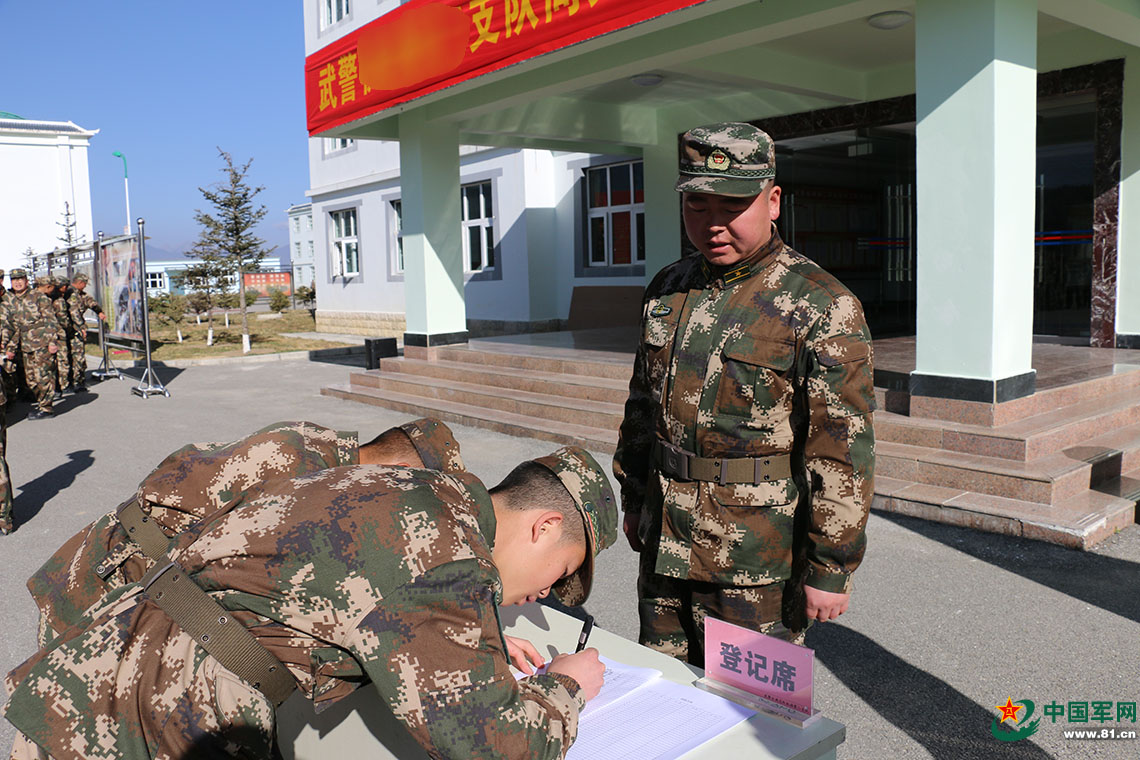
[806,623,1053,760]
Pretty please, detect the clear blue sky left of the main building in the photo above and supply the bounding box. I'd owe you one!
[0,0,309,259]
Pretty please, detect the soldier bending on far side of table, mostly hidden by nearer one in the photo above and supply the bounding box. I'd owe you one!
[27,418,464,647]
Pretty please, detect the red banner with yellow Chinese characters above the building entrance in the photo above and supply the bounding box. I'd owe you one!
[304,0,707,136]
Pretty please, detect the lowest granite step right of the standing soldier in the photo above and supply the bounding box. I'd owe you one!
[871,479,1137,550]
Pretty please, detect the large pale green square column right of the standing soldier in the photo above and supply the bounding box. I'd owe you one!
[910,0,1037,410]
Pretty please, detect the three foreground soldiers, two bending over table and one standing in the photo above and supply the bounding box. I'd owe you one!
[5,123,874,760]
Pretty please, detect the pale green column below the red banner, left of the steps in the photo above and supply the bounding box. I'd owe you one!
[400,109,467,356]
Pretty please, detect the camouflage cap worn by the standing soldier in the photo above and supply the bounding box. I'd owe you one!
[677,122,776,197]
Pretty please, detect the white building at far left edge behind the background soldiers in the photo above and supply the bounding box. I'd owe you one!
[0,112,98,270]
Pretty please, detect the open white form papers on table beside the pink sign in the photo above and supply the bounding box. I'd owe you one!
[567,657,756,760]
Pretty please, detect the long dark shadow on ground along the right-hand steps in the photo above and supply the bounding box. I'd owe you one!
[876,510,1140,622]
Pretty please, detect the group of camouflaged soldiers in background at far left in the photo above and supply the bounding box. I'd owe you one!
[0,269,105,536]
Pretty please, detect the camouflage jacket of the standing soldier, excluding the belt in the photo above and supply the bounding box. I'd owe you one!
[613,231,874,591]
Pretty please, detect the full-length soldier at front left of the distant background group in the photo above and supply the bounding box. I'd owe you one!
[0,269,62,419]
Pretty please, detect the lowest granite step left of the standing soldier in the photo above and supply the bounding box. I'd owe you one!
[320,383,618,455]
